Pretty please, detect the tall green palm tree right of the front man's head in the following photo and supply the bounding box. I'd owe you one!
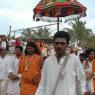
[69,19,92,45]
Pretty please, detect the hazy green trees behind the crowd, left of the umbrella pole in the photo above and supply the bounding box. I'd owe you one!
[22,27,51,39]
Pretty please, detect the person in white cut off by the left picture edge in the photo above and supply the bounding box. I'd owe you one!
[0,47,11,95]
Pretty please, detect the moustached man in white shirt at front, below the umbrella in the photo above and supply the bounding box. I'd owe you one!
[35,31,86,95]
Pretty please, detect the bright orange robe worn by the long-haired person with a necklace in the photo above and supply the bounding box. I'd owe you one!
[18,54,41,95]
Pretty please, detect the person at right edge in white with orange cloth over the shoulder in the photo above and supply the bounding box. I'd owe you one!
[83,48,95,95]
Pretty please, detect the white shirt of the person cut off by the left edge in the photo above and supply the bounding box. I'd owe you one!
[0,55,11,80]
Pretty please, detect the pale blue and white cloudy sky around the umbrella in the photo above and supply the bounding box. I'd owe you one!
[0,0,95,35]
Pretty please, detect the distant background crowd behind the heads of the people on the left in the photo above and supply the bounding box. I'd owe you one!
[0,35,52,56]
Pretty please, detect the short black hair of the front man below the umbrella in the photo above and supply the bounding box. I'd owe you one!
[53,31,70,44]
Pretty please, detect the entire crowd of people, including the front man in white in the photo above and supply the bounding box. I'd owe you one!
[0,31,95,95]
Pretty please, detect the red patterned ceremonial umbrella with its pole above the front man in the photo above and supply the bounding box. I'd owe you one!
[33,0,87,31]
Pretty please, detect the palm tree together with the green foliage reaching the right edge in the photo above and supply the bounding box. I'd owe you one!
[68,19,95,47]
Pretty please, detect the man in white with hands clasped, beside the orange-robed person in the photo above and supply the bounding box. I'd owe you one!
[7,46,23,95]
